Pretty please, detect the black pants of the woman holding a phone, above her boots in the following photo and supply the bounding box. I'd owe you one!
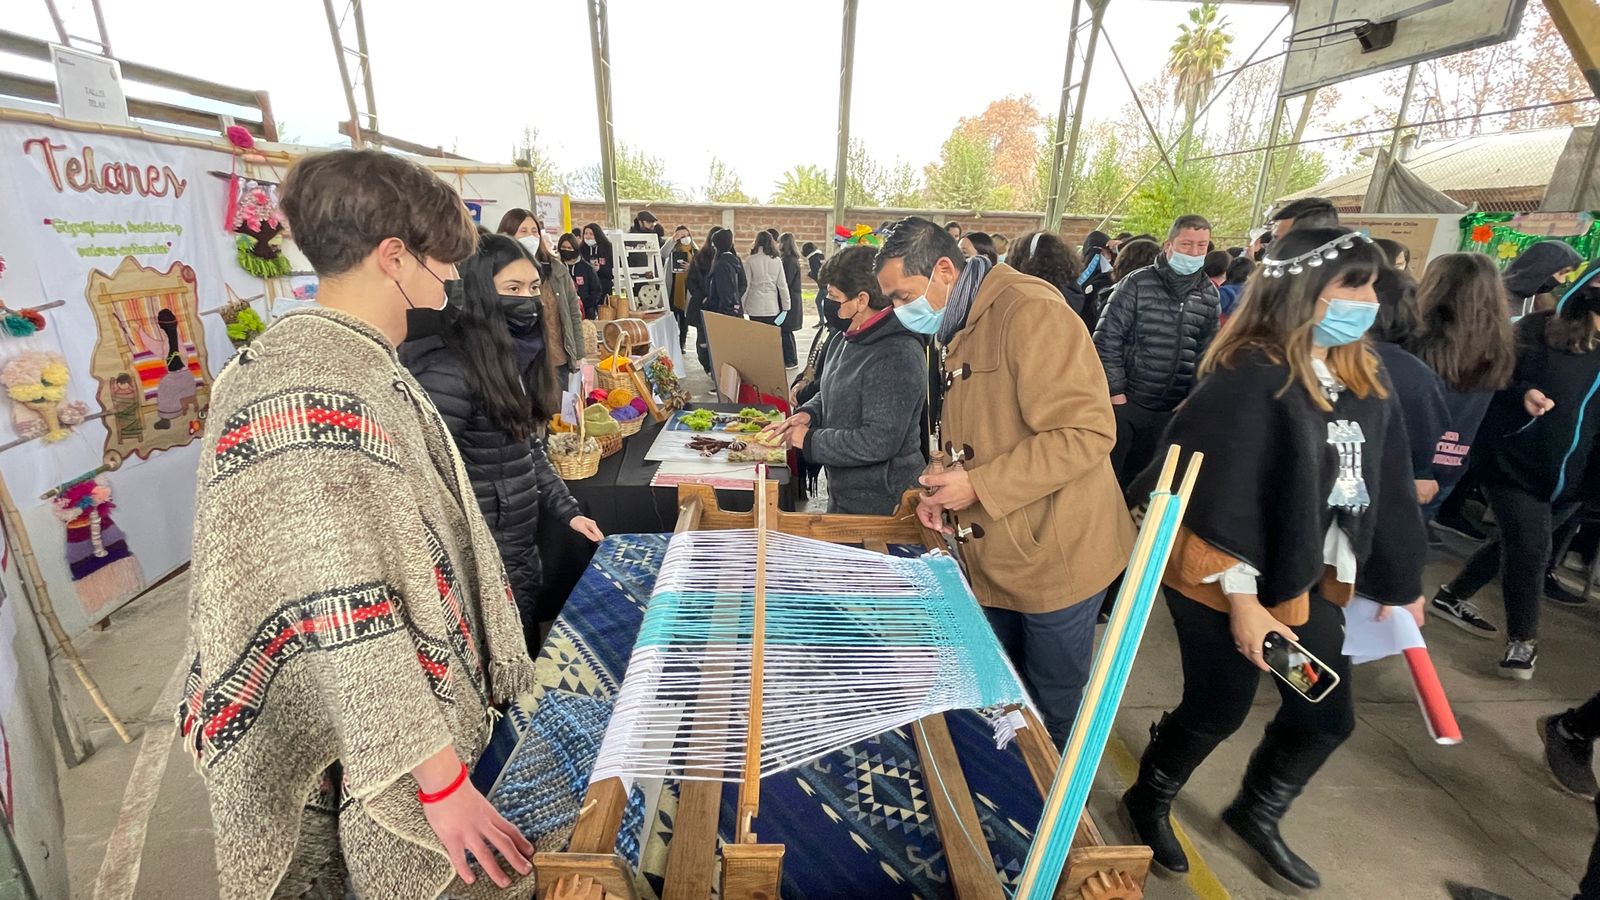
[1165,588,1355,785]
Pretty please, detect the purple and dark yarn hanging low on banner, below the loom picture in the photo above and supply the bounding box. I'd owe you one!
[51,474,144,617]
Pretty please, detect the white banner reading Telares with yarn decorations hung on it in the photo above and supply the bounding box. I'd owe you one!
[0,122,251,631]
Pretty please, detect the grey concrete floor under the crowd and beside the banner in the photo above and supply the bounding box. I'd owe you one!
[61,313,1600,900]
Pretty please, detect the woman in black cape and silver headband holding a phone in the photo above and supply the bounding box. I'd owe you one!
[1123,227,1427,889]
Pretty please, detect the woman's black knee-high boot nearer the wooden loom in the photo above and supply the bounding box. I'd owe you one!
[1122,713,1227,874]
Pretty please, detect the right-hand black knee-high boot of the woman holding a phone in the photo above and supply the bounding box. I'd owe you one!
[1222,722,1344,890]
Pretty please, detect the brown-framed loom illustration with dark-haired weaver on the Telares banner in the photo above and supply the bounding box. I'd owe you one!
[86,256,211,466]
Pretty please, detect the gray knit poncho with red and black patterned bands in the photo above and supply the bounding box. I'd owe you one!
[178,307,533,900]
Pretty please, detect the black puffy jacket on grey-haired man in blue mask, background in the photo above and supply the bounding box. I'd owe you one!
[1094,256,1218,410]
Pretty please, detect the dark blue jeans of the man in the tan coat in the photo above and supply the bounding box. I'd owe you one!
[984,591,1106,749]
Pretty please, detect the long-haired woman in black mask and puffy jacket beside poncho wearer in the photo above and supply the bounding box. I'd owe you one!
[400,234,603,655]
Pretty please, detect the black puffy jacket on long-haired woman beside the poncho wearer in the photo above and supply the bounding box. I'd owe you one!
[400,335,579,637]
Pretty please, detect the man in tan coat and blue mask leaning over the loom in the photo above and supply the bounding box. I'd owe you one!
[877,216,1133,746]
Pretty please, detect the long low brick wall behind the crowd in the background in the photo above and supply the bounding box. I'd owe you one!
[573,200,1099,253]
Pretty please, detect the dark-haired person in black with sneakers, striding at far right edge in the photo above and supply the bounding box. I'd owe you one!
[1424,261,1600,681]
